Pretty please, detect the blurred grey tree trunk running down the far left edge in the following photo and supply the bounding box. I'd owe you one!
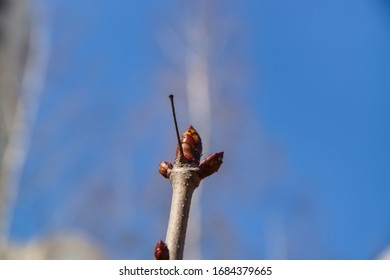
[0,0,31,251]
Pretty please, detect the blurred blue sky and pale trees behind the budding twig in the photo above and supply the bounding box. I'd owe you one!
[0,0,390,259]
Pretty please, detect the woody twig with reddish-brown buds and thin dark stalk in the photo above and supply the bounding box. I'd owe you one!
[154,95,223,260]
